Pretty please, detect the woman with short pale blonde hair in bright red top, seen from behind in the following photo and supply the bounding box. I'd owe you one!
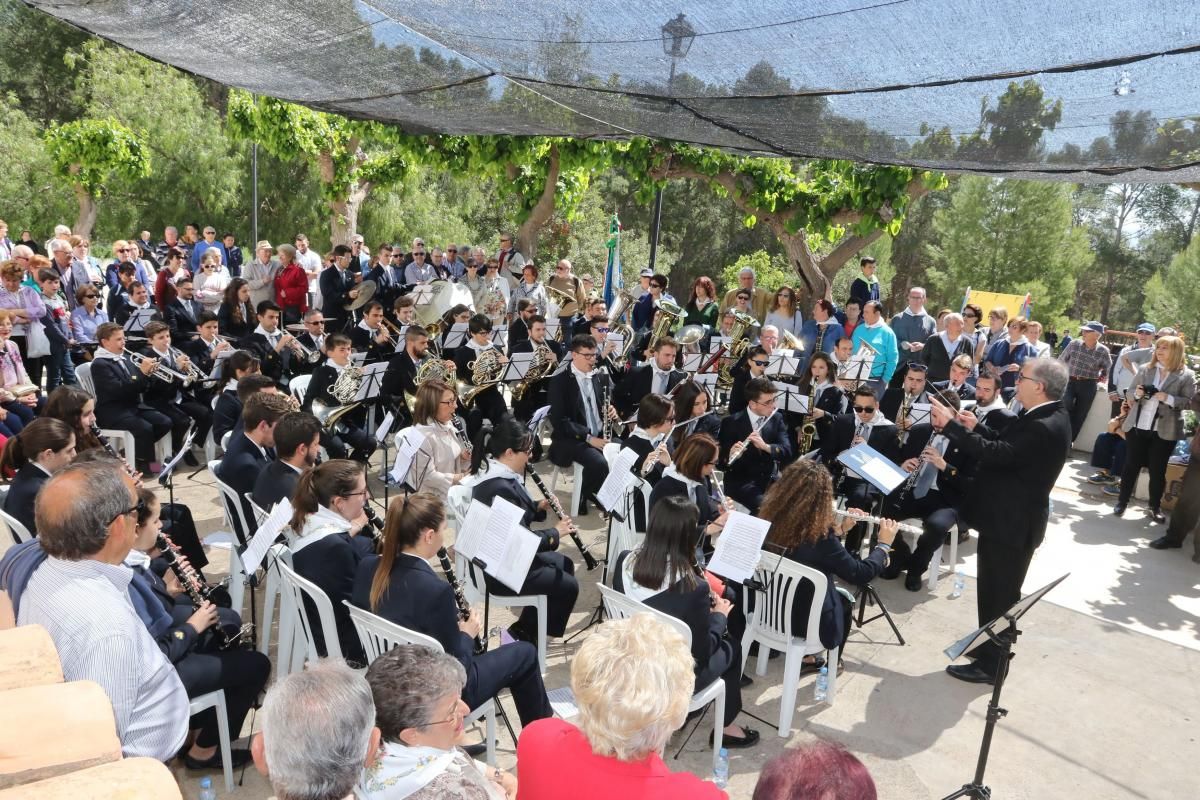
[517,614,727,800]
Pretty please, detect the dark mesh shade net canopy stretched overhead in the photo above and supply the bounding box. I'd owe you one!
[29,0,1200,182]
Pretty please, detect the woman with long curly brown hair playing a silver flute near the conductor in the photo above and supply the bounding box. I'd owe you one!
[760,458,899,667]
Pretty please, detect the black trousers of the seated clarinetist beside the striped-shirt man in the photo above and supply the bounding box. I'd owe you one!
[175,650,271,747]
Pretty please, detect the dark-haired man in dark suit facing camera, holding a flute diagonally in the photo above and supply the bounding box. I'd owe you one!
[720,378,792,513]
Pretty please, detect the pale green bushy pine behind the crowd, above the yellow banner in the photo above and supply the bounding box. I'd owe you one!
[929,178,1092,318]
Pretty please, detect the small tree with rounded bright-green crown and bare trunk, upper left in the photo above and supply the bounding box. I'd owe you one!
[46,118,150,236]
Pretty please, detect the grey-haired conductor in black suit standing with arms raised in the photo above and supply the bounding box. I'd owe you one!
[932,359,1072,684]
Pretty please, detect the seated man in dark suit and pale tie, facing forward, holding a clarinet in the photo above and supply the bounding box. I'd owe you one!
[548,333,617,513]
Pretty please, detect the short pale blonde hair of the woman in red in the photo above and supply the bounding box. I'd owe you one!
[571,614,695,762]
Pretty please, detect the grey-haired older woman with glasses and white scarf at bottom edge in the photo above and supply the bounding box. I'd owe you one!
[355,644,517,800]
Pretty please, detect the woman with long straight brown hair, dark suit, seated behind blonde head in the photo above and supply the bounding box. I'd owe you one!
[352,492,552,726]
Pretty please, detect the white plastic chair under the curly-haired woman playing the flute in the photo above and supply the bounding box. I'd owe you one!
[742,551,839,739]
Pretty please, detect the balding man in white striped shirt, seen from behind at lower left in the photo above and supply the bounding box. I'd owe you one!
[17,461,188,762]
